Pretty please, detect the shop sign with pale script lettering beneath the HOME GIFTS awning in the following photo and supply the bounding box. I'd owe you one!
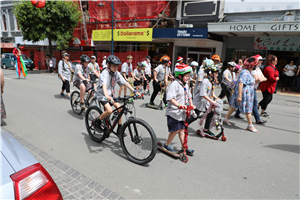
[253,37,300,51]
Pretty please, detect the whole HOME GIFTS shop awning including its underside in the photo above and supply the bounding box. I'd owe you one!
[208,21,300,37]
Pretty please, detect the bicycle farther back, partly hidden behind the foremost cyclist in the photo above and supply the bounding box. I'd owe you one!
[70,81,98,115]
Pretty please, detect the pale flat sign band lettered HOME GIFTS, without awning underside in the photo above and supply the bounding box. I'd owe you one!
[208,21,300,33]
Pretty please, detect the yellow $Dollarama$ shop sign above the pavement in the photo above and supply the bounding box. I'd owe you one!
[92,28,153,41]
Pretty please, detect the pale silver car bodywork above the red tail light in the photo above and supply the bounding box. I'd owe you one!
[0,130,38,172]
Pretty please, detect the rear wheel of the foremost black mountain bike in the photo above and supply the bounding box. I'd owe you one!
[85,106,105,143]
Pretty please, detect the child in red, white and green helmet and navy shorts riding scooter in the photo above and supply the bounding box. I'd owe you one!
[163,63,195,155]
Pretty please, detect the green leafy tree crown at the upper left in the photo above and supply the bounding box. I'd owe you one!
[13,0,82,55]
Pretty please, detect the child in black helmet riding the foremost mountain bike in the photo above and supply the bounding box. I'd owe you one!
[95,55,139,134]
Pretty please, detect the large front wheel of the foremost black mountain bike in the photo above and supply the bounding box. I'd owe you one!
[120,118,157,165]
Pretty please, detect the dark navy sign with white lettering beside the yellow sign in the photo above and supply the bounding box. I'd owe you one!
[153,28,207,39]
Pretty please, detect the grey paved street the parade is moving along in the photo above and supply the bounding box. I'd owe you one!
[2,70,300,199]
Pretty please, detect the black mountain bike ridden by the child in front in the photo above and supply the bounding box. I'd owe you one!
[85,97,157,165]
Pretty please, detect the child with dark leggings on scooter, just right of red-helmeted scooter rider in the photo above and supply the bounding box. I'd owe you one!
[188,59,219,136]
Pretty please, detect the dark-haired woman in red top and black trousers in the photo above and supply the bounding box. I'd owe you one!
[258,54,279,117]
